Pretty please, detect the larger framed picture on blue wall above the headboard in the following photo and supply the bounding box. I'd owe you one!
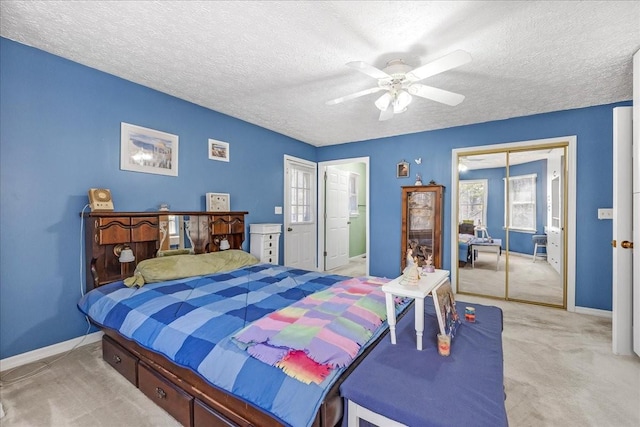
[120,122,178,176]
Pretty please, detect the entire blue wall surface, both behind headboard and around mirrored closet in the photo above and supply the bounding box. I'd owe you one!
[0,38,630,359]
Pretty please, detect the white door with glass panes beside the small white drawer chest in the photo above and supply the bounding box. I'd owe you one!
[284,156,317,270]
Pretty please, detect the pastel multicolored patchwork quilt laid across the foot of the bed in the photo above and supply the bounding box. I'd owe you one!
[233,278,389,384]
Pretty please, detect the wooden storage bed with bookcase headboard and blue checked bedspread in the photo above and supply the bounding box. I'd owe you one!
[78,212,409,426]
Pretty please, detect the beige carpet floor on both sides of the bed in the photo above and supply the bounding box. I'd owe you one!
[0,295,640,427]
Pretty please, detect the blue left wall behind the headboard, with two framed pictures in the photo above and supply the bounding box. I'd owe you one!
[0,38,316,358]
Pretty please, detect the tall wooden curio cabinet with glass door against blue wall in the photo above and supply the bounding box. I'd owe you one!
[400,185,444,271]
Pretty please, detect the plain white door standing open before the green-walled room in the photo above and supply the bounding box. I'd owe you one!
[325,166,349,270]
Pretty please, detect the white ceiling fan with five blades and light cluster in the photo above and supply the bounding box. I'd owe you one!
[327,50,471,121]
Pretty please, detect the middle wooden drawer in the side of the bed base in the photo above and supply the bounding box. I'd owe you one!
[138,362,193,427]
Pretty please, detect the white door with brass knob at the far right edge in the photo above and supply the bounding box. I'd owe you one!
[612,107,633,355]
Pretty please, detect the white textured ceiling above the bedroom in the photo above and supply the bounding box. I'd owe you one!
[0,0,640,146]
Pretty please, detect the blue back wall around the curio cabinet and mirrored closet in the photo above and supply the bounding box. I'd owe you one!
[317,102,631,310]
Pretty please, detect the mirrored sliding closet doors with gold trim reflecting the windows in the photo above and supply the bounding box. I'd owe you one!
[451,137,576,311]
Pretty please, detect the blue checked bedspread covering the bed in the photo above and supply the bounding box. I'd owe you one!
[78,264,406,426]
